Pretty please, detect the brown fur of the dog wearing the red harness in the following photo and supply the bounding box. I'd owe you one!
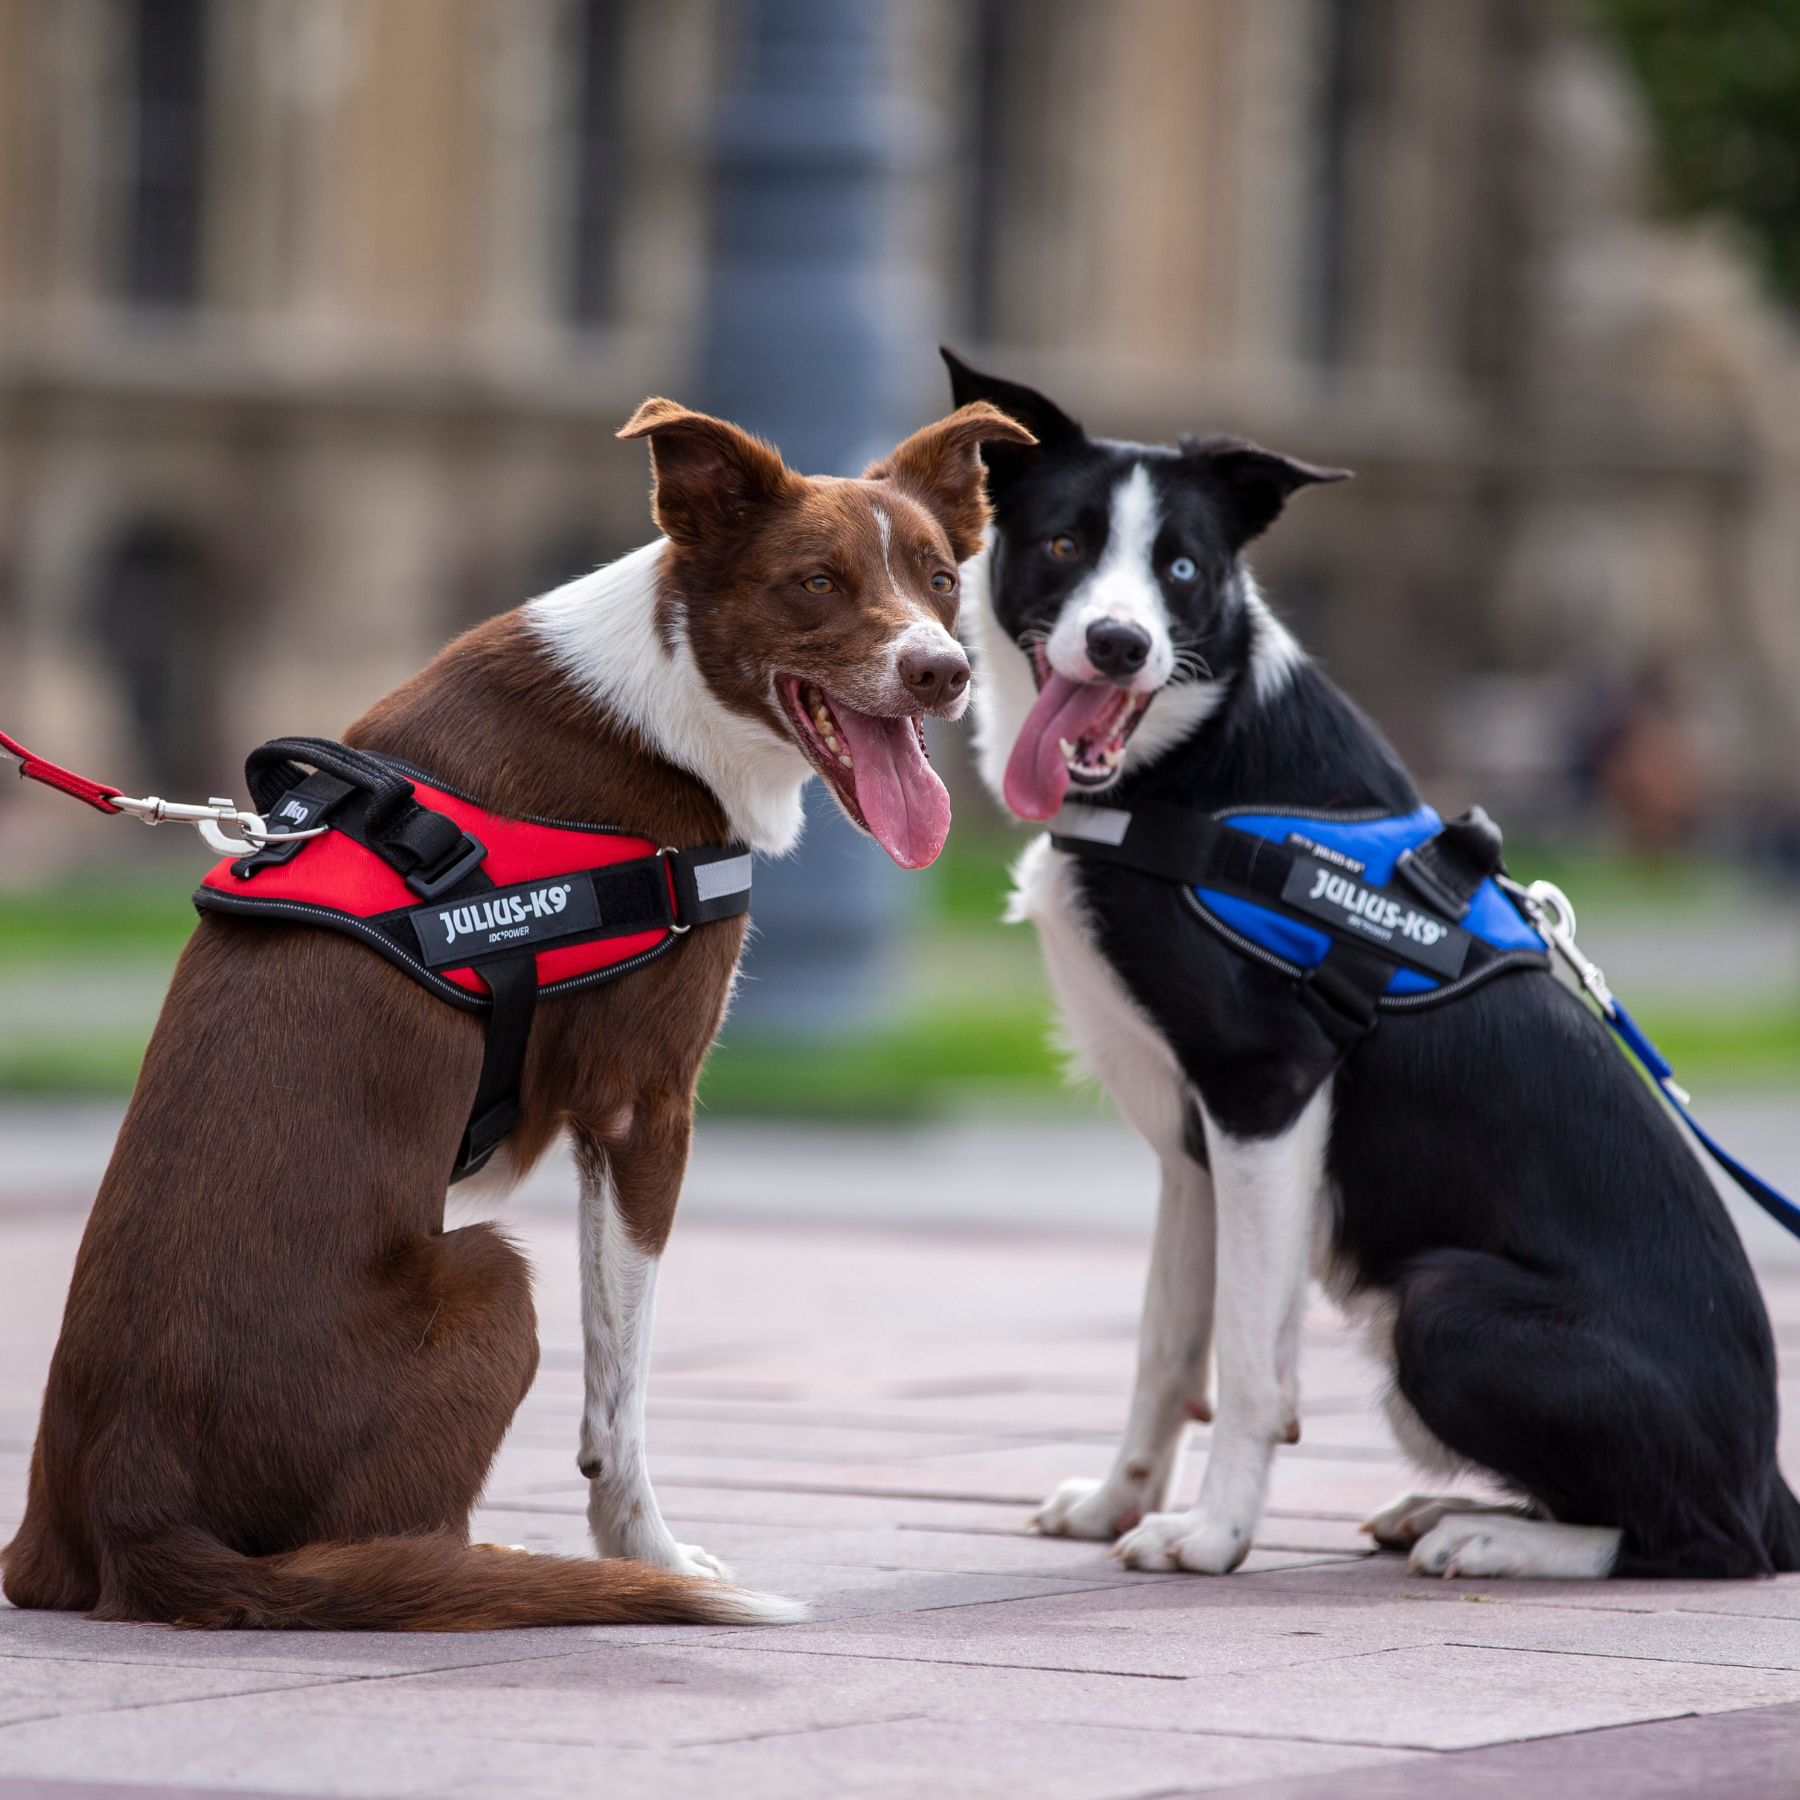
[0,401,1029,1631]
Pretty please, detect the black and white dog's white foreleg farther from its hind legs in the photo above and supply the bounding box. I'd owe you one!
[1031,1154,1213,1537]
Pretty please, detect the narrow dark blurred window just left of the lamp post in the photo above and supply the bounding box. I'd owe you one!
[565,0,626,326]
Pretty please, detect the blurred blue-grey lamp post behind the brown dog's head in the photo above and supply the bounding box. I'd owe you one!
[698,0,907,1035]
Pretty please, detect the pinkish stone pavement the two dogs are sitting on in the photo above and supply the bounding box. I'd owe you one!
[0,1100,1800,1800]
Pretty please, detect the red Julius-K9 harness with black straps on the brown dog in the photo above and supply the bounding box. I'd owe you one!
[182,738,751,1181]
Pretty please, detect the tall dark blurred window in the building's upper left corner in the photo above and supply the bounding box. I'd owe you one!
[121,0,207,306]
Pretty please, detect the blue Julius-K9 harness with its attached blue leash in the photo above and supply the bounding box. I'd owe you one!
[1049,801,1800,1237]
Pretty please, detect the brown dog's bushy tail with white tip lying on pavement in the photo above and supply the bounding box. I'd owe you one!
[94,1532,806,1631]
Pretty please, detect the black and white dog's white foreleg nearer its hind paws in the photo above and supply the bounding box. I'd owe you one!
[1114,1082,1330,1575]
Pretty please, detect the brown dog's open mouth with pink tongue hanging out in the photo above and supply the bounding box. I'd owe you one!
[776,675,950,869]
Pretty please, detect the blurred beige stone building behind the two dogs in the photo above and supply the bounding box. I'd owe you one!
[0,0,1800,877]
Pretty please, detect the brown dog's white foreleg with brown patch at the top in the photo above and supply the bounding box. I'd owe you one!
[580,1121,727,1575]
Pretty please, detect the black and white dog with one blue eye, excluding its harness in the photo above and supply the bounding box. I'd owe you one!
[945,353,1800,1577]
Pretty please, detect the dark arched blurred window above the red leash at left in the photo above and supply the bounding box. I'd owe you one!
[92,520,218,799]
